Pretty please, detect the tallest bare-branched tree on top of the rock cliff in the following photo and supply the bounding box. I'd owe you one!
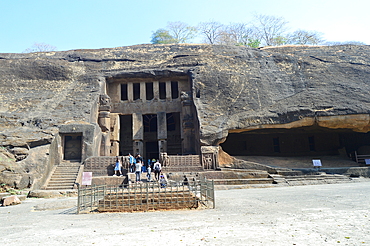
[254,15,288,45]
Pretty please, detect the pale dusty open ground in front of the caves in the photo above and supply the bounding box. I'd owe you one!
[0,182,370,246]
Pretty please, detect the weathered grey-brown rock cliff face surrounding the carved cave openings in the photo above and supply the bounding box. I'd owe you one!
[0,45,370,188]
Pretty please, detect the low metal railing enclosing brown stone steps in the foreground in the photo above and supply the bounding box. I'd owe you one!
[77,180,215,213]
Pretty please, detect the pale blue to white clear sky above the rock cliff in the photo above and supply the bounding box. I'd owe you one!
[0,0,370,53]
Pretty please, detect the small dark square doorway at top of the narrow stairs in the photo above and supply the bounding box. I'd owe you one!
[64,133,82,161]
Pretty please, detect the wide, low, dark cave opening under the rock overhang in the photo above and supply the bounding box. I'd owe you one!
[220,126,370,156]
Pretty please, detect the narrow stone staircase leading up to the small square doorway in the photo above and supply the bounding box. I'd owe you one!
[45,161,81,190]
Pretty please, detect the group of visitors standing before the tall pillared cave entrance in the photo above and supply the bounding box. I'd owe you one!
[113,153,164,183]
